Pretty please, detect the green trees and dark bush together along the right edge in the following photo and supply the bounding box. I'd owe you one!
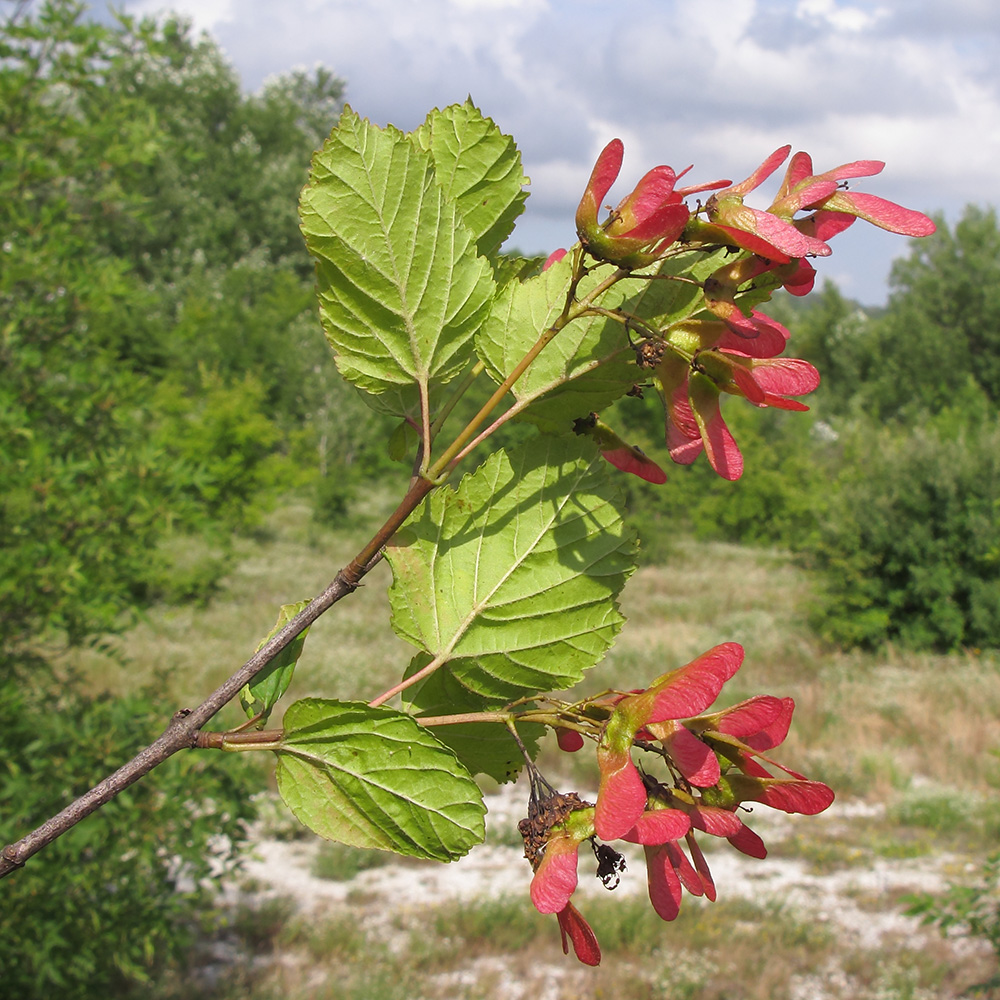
[752,214,1000,649]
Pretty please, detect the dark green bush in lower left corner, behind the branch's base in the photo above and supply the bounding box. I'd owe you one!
[0,668,253,1000]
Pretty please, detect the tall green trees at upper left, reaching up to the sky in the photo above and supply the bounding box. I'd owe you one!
[0,0,352,646]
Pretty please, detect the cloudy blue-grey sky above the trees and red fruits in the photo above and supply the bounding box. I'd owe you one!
[125,0,1000,304]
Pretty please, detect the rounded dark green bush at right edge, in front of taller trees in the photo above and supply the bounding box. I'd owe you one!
[802,411,1000,650]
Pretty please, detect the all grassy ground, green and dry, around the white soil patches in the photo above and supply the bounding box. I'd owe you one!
[58,498,1000,1000]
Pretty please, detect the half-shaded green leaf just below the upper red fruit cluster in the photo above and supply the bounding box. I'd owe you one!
[476,257,644,430]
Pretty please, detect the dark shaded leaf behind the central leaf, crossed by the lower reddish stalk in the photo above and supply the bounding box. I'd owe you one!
[403,653,545,784]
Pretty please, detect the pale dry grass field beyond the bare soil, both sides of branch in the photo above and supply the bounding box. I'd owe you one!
[64,502,1000,800]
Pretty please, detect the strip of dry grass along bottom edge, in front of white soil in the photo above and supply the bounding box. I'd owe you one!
[170,898,989,1000]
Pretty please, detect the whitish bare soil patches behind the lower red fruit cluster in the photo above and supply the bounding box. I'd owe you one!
[234,782,954,949]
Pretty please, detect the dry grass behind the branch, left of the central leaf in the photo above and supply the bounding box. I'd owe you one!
[62,502,413,721]
